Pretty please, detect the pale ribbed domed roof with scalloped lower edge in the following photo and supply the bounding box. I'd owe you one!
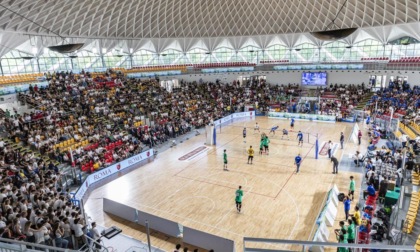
[0,0,420,56]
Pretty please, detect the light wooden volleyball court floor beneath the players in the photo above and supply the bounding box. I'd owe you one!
[86,117,360,251]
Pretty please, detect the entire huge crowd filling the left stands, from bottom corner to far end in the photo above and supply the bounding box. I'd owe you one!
[0,70,298,248]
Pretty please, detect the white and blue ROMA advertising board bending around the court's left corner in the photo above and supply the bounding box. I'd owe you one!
[74,149,153,200]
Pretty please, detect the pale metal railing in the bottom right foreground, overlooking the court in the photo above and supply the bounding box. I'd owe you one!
[243,237,416,252]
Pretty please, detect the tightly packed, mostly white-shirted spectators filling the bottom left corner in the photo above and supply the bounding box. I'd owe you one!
[0,159,86,248]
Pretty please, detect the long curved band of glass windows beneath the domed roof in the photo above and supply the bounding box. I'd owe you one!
[0,39,420,75]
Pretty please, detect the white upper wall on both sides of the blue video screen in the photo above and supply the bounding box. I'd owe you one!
[160,70,420,86]
